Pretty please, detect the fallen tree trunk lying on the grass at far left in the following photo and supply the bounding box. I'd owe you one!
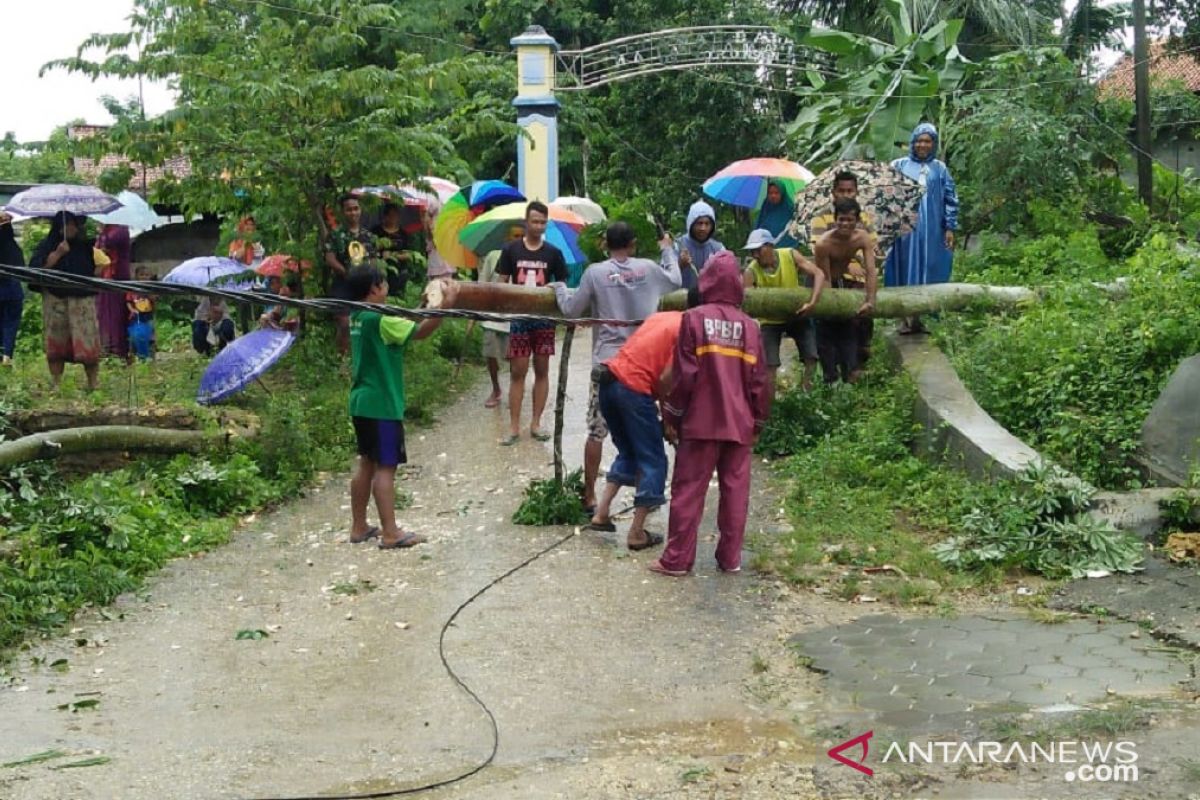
[0,425,226,468]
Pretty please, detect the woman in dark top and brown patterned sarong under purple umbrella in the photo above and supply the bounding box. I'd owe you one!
[29,211,100,391]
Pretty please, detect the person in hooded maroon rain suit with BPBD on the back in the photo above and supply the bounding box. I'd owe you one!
[650,251,770,577]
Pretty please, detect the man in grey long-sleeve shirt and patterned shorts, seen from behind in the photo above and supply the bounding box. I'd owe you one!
[552,222,683,520]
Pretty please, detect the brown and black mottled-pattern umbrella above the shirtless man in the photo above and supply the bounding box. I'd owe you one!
[787,161,925,253]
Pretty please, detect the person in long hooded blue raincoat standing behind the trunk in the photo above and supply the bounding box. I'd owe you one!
[883,122,959,333]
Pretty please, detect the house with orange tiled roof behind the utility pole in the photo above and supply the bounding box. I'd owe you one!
[1098,40,1200,175]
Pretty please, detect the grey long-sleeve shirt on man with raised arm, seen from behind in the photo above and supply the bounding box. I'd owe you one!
[553,247,683,365]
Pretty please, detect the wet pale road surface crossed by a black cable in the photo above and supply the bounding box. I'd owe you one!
[0,333,1200,800]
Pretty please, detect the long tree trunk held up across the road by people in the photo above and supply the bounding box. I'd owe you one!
[426,283,1038,319]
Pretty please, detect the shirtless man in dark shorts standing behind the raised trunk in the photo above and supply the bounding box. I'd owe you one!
[812,198,878,384]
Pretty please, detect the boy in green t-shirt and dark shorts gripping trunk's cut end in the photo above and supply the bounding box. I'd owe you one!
[346,264,457,549]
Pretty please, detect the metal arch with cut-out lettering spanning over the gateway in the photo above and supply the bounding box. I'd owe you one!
[558,25,817,91]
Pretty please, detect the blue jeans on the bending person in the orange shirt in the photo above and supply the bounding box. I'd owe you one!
[600,380,667,509]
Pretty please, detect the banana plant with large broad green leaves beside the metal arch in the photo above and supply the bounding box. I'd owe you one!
[785,0,973,169]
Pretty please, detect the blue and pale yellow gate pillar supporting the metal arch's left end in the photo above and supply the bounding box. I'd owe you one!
[510,25,558,203]
